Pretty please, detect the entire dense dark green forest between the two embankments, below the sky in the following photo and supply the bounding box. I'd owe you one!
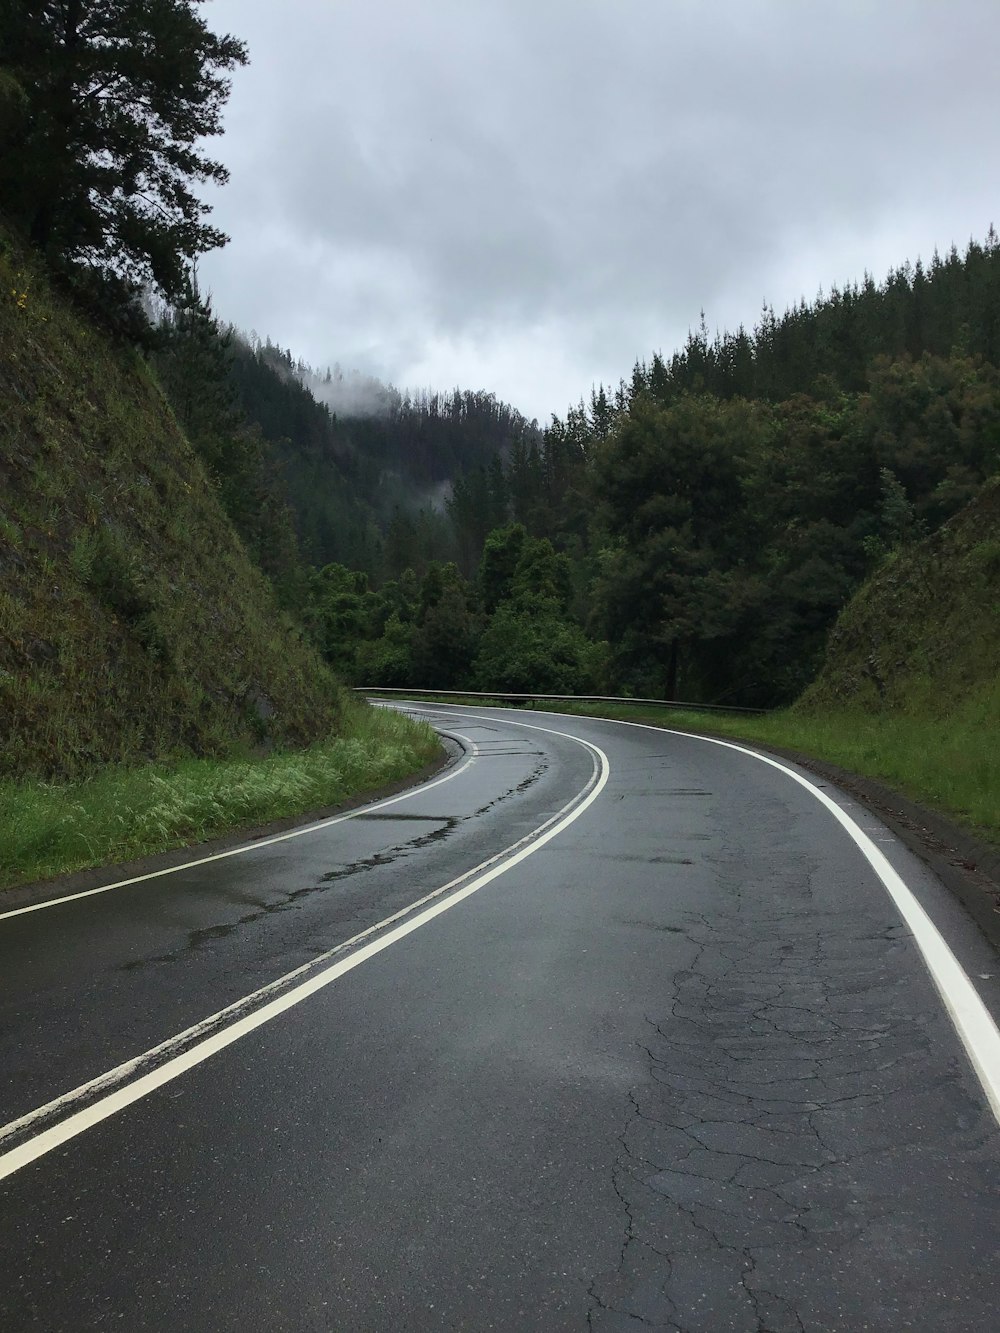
[156,228,1000,706]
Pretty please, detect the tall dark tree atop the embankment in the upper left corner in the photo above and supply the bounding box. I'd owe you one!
[0,0,247,297]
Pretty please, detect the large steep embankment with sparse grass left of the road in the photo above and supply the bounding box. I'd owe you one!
[0,236,341,777]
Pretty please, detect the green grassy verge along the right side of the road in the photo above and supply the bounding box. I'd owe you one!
[365,685,1000,844]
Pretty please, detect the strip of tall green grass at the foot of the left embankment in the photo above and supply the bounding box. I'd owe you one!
[0,702,440,888]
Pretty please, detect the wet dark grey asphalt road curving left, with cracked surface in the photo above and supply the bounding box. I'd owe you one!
[0,708,1000,1333]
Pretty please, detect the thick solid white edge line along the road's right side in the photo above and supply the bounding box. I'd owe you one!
[432,704,1000,1124]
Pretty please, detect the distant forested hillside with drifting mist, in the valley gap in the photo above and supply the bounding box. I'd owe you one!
[227,331,541,579]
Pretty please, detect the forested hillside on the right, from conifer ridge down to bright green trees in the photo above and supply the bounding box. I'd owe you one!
[270,229,1000,706]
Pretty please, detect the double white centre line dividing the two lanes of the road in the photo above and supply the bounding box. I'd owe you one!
[0,718,611,1180]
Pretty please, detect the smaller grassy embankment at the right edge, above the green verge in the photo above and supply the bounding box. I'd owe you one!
[799,479,1000,728]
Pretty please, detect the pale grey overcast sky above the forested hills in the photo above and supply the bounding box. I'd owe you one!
[201,0,1000,423]
